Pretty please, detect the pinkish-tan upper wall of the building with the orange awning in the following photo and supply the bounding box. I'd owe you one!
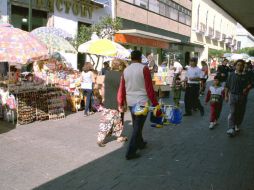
[117,0,191,36]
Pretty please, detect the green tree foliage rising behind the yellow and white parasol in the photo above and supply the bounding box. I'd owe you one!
[72,16,122,48]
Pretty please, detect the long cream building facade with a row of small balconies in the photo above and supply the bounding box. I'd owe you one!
[191,0,237,61]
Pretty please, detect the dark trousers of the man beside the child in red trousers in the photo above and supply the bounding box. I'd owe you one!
[228,94,247,129]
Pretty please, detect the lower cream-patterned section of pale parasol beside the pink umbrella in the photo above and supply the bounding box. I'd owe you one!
[33,33,77,53]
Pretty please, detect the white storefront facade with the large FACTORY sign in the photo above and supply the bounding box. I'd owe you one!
[0,0,112,69]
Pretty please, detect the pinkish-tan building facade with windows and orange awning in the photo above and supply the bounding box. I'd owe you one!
[113,0,192,63]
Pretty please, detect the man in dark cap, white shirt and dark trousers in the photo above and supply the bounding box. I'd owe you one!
[184,57,204,116]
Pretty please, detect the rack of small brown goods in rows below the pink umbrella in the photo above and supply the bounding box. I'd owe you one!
[14,87,65,125]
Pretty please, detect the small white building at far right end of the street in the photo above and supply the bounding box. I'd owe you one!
[236,23,254,49]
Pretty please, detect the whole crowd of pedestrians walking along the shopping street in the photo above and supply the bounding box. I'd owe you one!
[81,50,254,160]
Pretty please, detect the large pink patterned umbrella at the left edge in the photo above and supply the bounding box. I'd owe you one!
[0,24,48,64]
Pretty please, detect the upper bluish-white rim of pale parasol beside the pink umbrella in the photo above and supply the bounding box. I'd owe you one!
[31,27,72,40]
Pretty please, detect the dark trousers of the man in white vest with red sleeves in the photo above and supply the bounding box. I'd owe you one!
[126,107,147,156]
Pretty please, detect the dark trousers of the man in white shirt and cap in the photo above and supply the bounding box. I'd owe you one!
[184,84,203,114]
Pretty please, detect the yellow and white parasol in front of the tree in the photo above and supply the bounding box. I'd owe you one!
[78,39,130,58]
